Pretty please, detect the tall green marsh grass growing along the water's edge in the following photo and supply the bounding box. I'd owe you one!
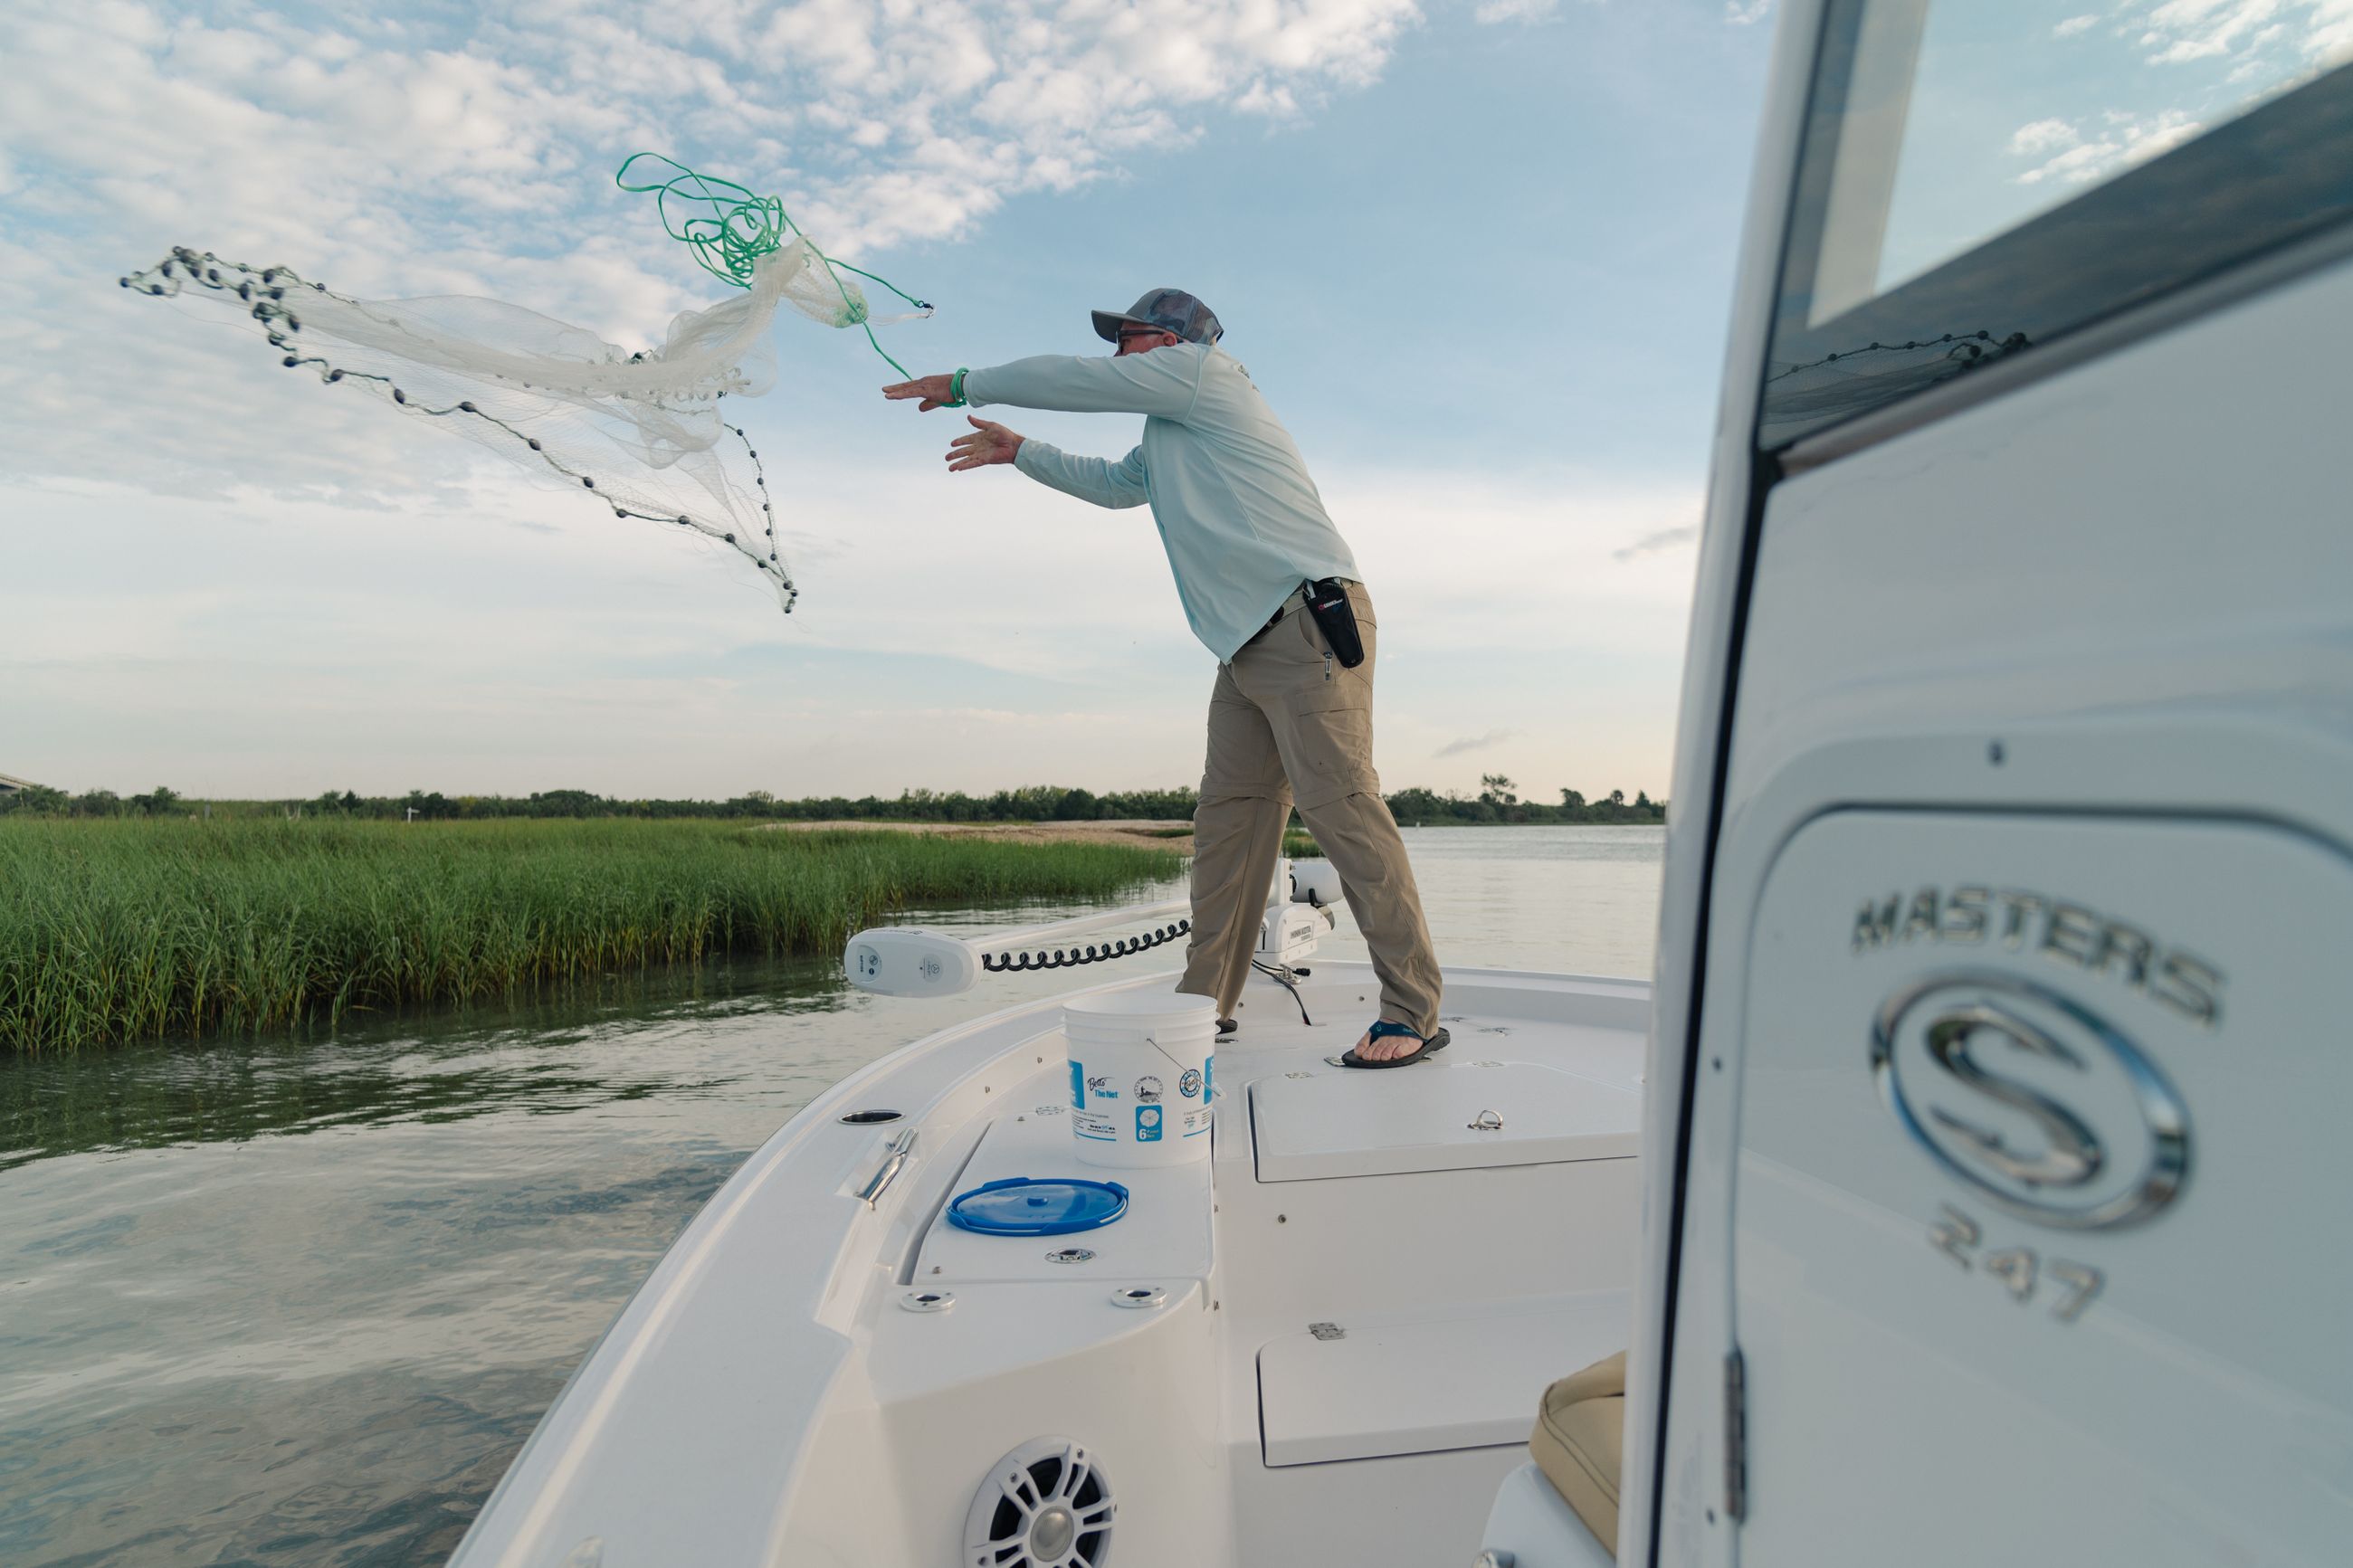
[0,818,1181,1050]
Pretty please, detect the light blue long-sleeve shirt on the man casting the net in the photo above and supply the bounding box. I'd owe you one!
[965,343,1358,660]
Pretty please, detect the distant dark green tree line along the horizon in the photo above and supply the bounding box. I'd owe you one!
[0,774,1666,828]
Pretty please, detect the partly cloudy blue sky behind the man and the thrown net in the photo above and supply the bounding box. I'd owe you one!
[0,0,1769,799]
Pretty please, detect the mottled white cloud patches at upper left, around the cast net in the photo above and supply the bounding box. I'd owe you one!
[0,0,1419,494]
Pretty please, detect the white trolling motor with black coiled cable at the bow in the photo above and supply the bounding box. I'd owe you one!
[843,860,1338,997]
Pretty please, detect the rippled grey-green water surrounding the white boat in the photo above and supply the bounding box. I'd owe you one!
[0,828,1663,1568]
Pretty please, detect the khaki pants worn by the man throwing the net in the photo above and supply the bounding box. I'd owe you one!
[1176,585,1440,1037]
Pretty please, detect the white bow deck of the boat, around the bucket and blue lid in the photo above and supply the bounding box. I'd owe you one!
[456,964,1650,1568]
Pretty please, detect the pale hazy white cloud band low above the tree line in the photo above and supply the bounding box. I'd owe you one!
[0,461,1699,797]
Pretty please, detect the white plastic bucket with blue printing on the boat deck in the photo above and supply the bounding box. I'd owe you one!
[1062,990,1216,1166]
